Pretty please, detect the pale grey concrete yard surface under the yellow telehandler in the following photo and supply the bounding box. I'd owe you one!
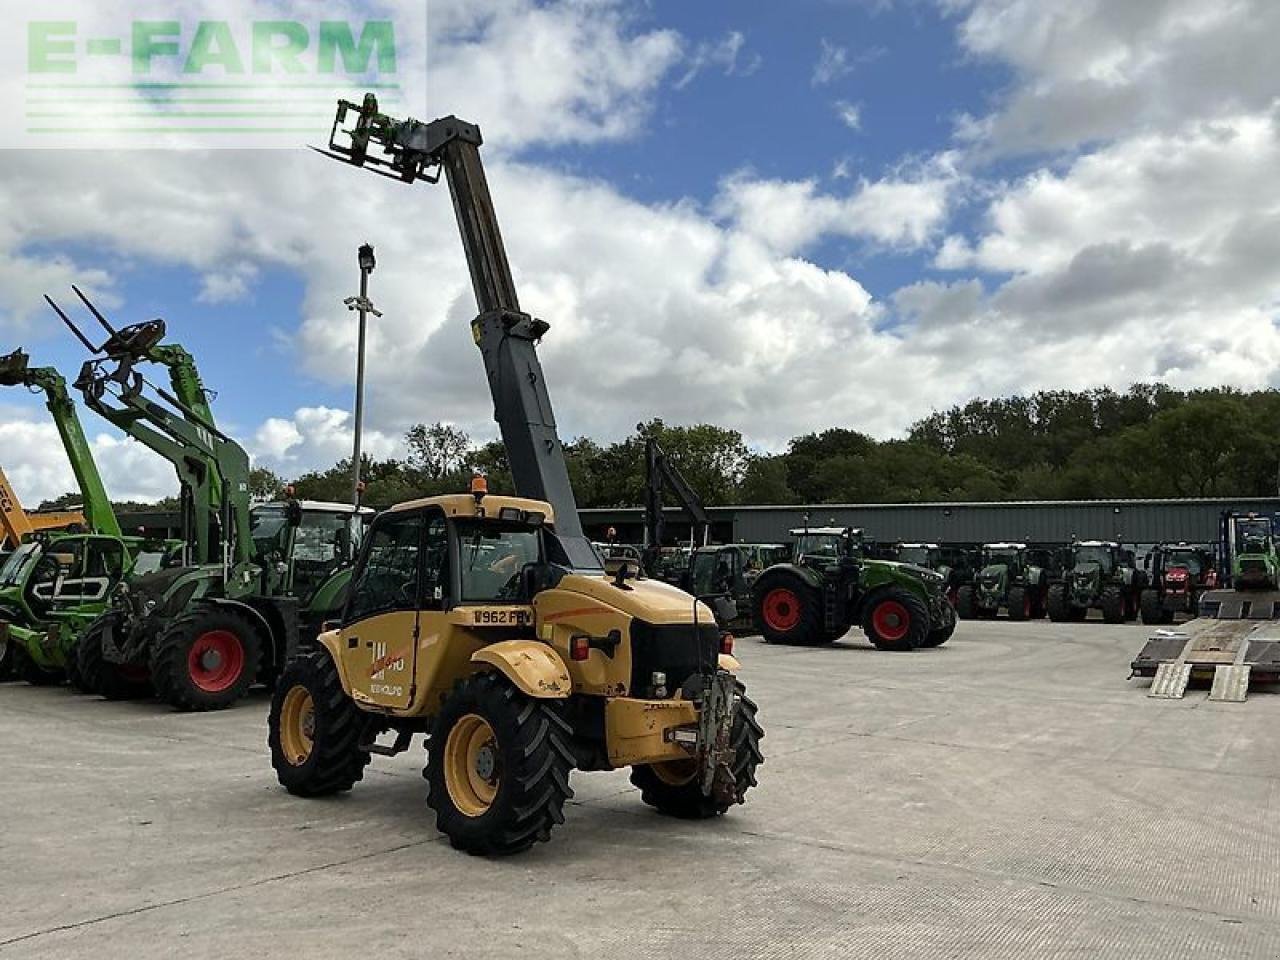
[0,621,1280,960]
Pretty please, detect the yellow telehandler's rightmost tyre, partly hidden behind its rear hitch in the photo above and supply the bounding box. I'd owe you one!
[631,684,764,820]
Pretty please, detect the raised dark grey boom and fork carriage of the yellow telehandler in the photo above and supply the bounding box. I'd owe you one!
[320,93,600,570]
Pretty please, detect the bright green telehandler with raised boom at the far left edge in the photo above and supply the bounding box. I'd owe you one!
[0,349,173,687]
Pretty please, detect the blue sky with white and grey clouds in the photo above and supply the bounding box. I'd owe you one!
[0,0,1280,503]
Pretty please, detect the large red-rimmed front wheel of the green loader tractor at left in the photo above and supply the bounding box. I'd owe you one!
[151,605,262,712]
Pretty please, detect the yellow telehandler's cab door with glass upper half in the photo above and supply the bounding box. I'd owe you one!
[339,511,425,708]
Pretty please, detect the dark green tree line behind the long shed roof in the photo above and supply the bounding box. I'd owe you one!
[41,384,1280,509]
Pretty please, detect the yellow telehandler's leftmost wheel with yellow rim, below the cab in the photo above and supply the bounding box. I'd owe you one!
[266,650,370,796]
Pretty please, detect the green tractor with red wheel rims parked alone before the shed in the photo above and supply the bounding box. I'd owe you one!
[753,527,956,650]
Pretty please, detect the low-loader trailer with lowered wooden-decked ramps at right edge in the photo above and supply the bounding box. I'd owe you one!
[1132,599,1280,703]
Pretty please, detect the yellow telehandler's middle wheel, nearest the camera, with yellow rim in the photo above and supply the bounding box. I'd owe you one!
[424,673,573,855]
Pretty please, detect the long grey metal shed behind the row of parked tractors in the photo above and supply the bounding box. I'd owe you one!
[581,497,1280,544]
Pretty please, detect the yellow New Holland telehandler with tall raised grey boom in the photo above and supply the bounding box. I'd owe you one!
[259,95,763,854]
